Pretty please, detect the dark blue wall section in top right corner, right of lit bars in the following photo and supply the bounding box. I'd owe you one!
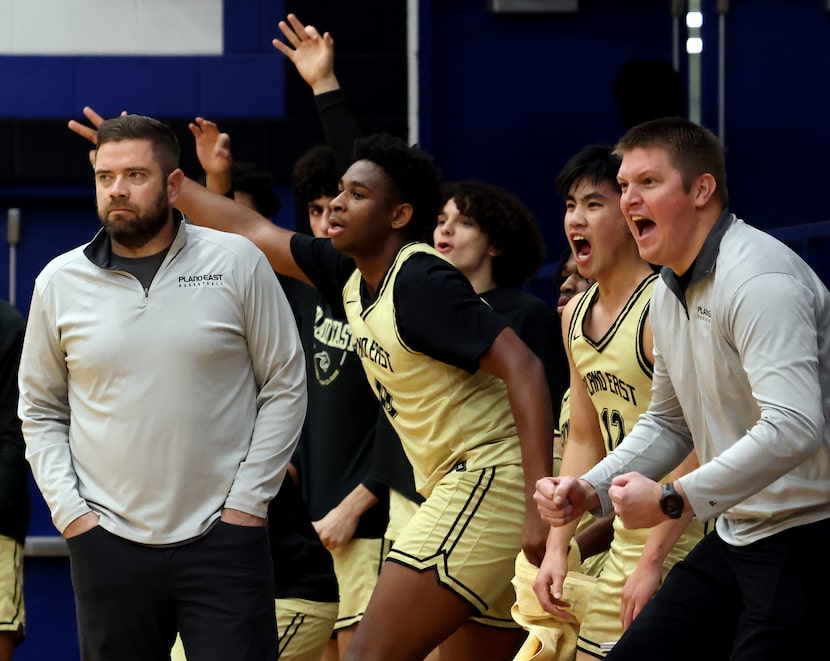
[711,0,830,228]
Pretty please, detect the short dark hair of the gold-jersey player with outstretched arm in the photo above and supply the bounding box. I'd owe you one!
[353,133,441,240]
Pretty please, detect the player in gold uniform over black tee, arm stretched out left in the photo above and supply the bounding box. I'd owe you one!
[166,136,554,661]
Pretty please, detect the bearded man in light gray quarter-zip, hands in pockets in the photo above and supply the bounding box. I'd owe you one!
[19,115,306,661]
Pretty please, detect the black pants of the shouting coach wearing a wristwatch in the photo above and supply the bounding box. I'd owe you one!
[607,519,830,661]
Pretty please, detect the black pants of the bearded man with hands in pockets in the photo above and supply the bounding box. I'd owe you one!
[68,521,277,661]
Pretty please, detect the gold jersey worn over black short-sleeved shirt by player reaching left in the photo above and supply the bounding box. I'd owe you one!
[343,243,521,497]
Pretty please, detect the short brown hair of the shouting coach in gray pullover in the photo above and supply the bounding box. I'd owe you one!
[614,117,729,208]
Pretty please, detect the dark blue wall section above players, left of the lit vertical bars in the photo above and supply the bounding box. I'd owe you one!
[422,0,671,258]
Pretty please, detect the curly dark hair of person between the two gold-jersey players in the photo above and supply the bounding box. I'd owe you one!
[443,180,545,287]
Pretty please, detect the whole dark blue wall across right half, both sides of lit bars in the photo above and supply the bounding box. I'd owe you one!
[422,0,830,255]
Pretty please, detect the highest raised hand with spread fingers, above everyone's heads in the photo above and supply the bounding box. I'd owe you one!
[271,14,340,95]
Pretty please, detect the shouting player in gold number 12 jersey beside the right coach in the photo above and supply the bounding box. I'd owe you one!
[534,146,702,660]
